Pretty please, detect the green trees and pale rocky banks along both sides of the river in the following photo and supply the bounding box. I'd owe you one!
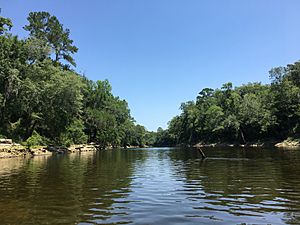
[0,12,300,158]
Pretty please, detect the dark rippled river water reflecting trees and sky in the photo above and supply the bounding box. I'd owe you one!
[0,148,300,225]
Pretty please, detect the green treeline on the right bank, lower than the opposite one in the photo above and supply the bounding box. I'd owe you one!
[156,62,300,146]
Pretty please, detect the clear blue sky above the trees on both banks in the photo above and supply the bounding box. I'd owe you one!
[0,0,300,130]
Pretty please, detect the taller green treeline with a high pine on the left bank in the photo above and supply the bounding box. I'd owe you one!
[0,12,154,148]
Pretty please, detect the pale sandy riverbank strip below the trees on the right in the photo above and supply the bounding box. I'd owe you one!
[193,138,300,148]
